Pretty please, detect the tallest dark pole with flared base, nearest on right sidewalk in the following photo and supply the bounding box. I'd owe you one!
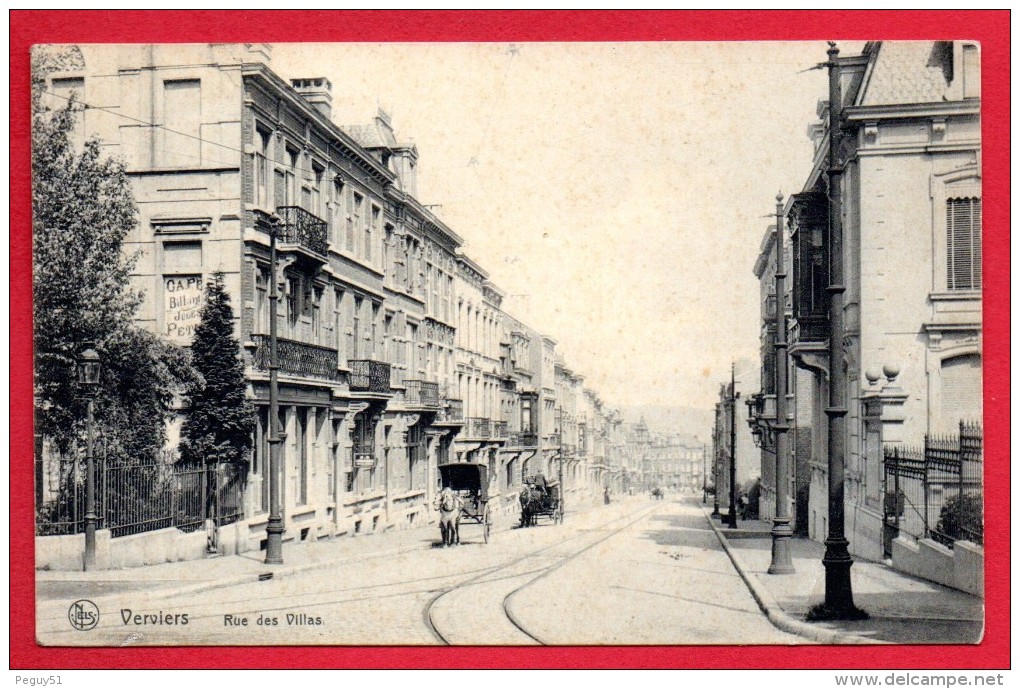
[808,43,867,620]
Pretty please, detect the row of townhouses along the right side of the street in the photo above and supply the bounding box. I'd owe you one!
[716,41,982,596]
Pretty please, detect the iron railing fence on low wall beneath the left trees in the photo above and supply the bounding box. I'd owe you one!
[36,448,247,538]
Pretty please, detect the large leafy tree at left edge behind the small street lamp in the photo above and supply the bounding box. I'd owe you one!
[32,52,193,463]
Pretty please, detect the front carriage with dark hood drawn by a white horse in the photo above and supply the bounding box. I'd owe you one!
[436,462,493,546]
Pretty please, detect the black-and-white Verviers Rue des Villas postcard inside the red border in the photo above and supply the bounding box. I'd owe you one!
[32,41,985,647]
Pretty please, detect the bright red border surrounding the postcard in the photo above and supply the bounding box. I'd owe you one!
[9,10,1010,670]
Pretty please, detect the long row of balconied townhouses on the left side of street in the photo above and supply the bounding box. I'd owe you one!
[33,44,669,567]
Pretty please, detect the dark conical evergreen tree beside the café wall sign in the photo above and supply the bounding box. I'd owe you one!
[181,273,255,467]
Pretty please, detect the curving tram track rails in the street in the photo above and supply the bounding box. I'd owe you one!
[422,503,661,645]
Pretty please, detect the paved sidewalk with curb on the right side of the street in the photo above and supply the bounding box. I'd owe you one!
[703,507,984,644]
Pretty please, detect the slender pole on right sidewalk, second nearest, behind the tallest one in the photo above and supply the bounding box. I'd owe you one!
[768,194,795,575]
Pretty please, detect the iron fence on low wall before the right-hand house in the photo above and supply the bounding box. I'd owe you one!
[884,423,983,554]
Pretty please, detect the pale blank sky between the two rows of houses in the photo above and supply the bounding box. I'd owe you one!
[272,42,863,408]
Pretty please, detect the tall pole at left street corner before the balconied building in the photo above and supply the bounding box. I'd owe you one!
[265,218,285,564]
